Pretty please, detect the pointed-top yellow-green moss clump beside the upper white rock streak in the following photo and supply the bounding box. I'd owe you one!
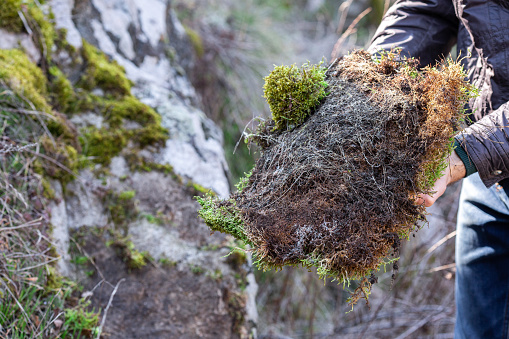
[80,41,132,96]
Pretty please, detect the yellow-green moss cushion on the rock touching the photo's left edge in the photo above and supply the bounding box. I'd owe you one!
[0,49,51,113]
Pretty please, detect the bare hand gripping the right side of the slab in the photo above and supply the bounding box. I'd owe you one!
[414,151,467,207]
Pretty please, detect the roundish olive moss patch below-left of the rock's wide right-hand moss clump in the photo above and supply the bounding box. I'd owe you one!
[80,127,127,165]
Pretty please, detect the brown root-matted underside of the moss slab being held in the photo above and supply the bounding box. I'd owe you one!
[198,51,475,304]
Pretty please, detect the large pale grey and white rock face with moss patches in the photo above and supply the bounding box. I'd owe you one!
[40,0,257,338]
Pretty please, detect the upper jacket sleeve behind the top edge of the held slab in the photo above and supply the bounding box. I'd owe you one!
[368,0,459,67]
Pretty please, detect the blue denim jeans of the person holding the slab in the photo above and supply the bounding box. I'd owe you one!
[455,173,509,339]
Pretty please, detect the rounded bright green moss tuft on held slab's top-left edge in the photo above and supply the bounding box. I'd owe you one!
[263,64,328,131]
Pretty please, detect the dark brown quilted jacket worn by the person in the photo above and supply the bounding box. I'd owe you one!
[369,0,509,187]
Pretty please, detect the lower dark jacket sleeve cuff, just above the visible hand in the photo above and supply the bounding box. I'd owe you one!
[456,102,509,187]
